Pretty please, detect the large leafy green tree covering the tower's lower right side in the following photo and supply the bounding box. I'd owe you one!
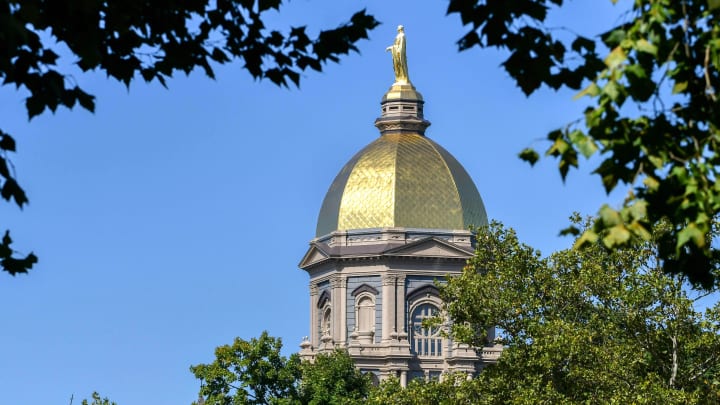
[442,217,720,403]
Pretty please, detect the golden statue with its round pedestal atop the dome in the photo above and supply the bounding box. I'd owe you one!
[375,25,430,135]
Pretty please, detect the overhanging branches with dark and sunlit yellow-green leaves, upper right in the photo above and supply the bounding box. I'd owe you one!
[448,0,720,288]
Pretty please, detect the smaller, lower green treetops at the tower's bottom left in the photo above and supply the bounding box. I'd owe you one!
[190,332,371,405]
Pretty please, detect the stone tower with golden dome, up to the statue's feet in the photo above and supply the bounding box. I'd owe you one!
[299,34,500,386]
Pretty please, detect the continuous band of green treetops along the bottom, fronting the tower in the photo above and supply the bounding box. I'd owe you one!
[191,215,720,404]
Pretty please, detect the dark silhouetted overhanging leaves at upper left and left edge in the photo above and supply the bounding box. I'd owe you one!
[0,0,378,275]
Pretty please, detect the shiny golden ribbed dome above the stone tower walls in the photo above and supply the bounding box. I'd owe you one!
[316,131,487,236]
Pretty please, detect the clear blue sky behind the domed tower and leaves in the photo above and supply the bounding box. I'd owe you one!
[0,0,708,405]
